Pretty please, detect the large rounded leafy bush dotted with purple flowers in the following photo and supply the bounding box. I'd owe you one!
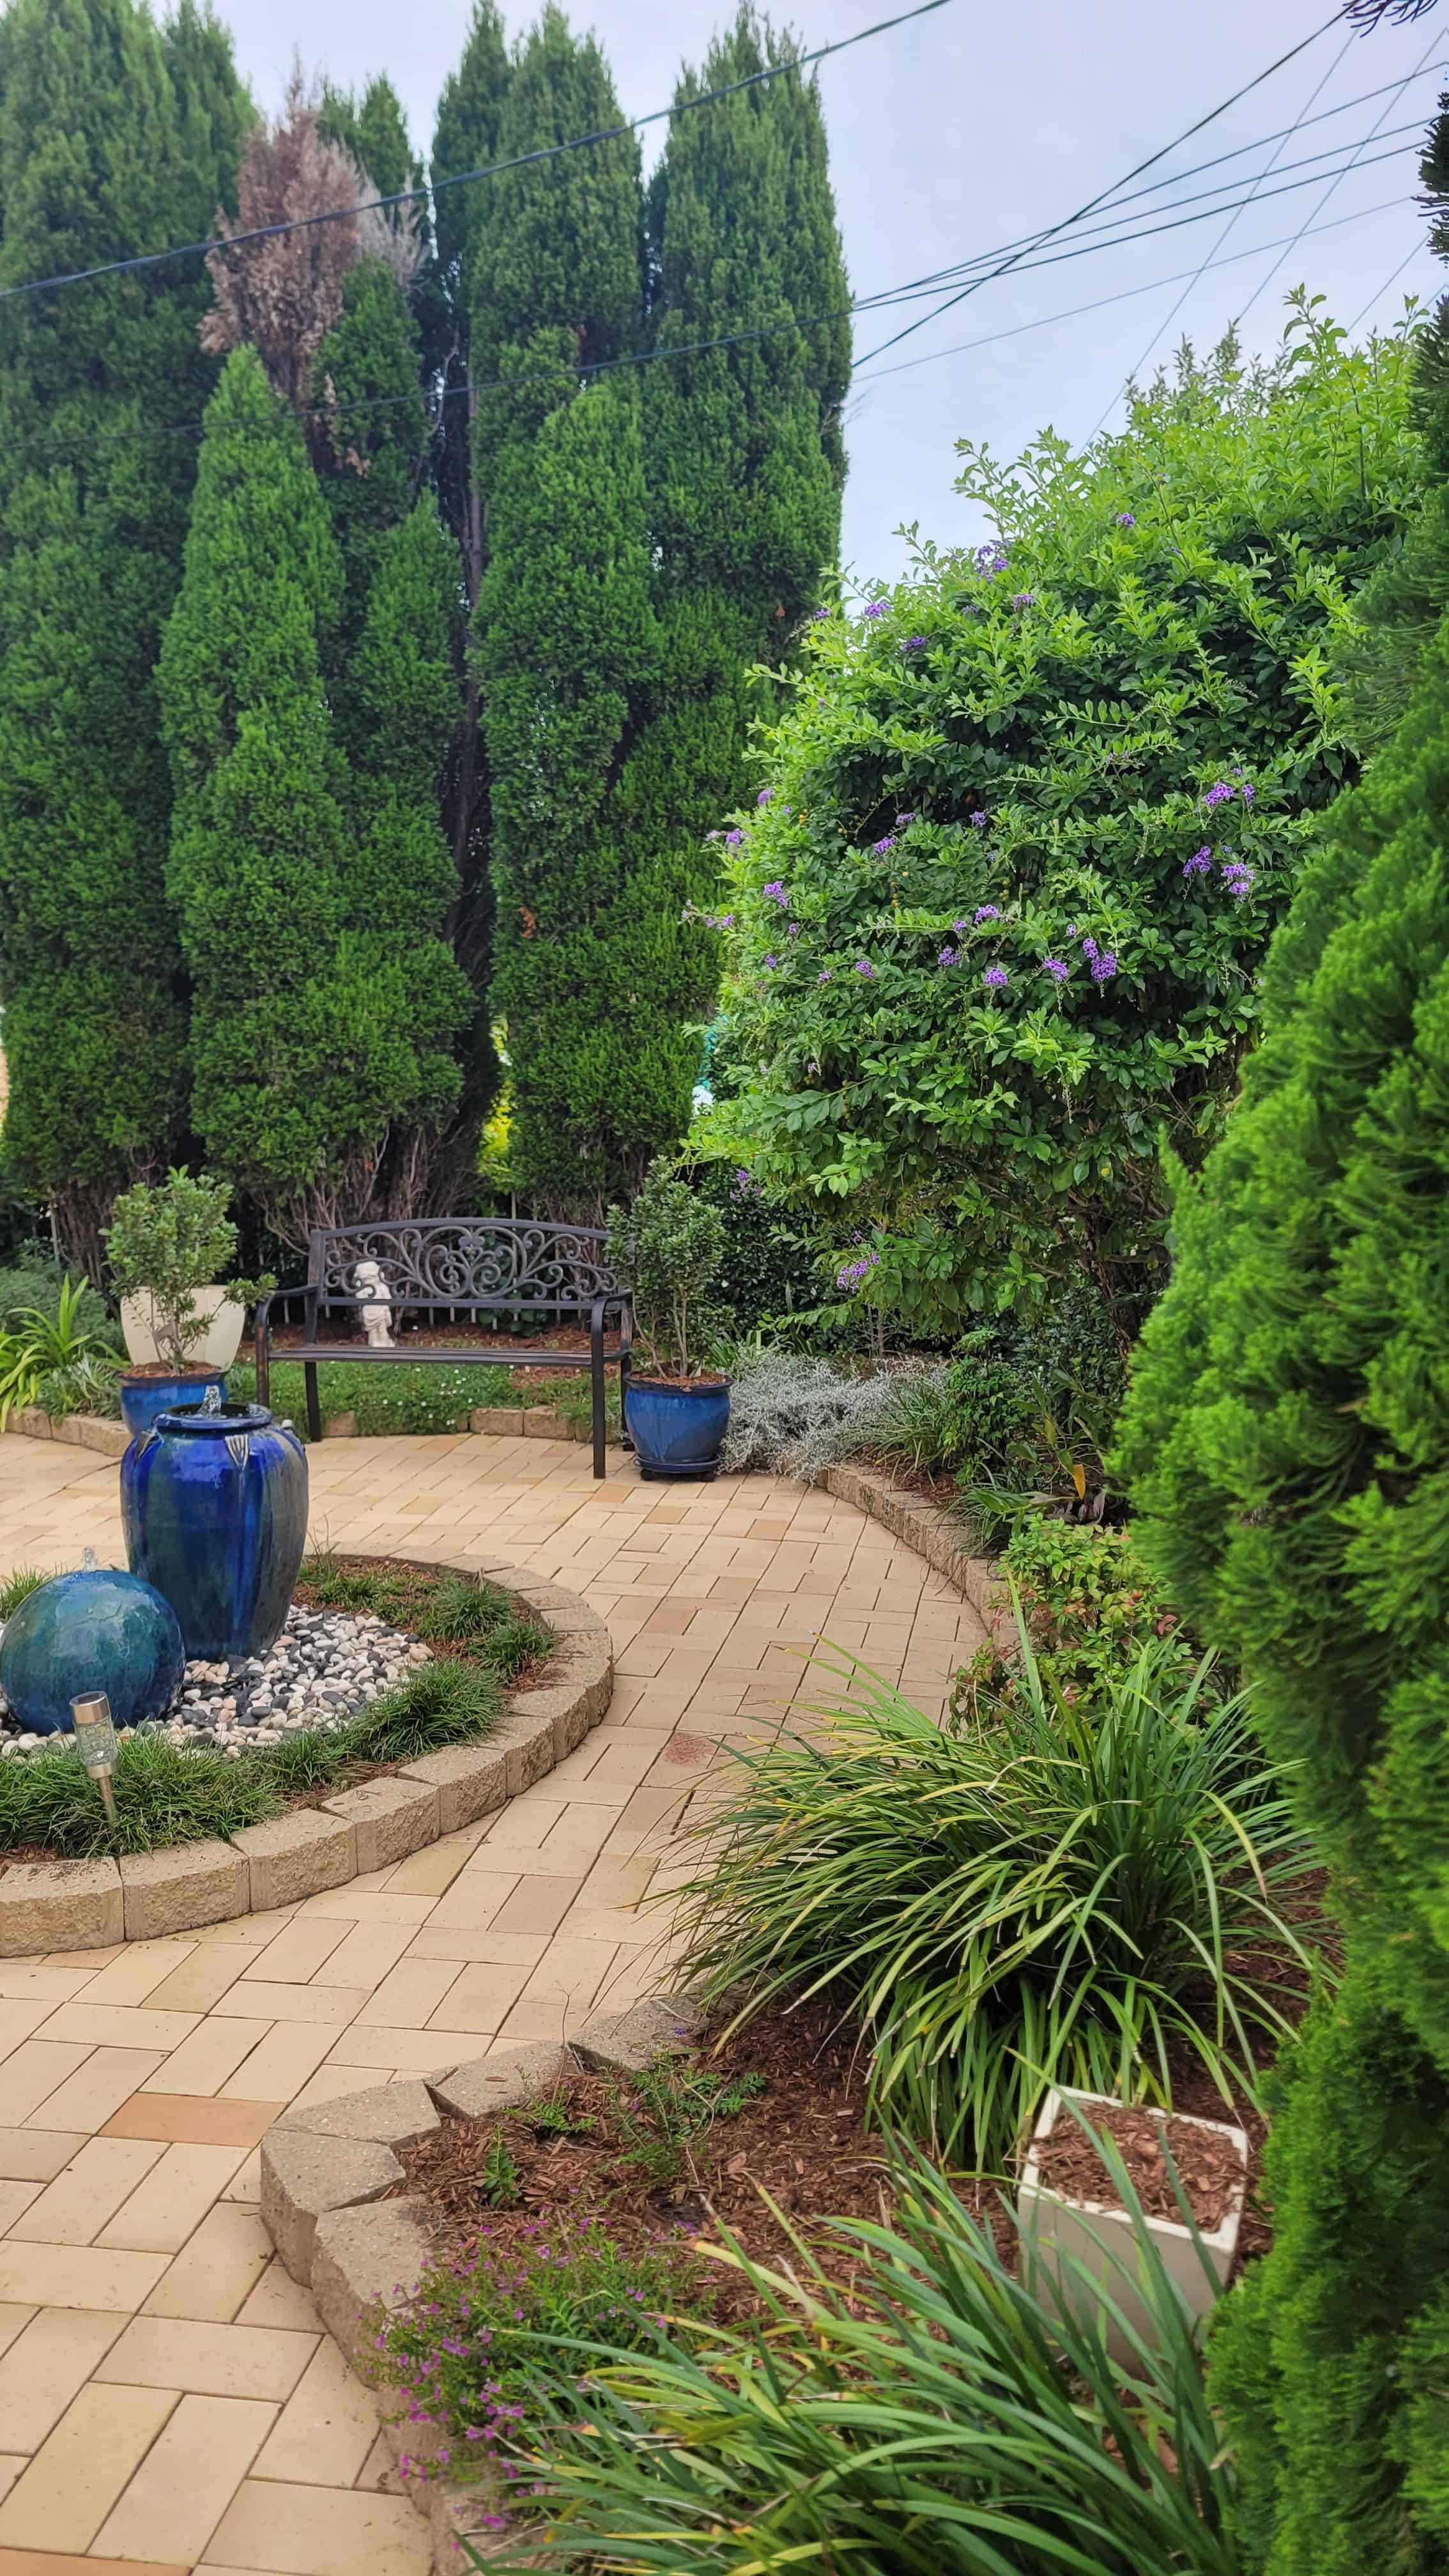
[724,309,1421,1335]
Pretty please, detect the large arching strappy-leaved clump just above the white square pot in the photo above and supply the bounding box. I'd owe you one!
[680,1633,1307,2169]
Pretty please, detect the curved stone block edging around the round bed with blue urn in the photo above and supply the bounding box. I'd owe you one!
[0,1548,613,1958]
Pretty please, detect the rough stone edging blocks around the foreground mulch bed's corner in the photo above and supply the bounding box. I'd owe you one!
[261,1994,699,2576]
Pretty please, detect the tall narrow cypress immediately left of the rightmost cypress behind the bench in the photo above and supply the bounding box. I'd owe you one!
[472,8,644,1213]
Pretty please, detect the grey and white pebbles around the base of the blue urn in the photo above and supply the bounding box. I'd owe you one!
[0,1602,431,1759]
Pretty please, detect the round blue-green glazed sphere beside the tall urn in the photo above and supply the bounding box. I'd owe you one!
[0,1566,186,1736]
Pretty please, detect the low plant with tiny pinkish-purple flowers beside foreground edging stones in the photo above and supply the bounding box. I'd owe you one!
[369,2210,702,2478]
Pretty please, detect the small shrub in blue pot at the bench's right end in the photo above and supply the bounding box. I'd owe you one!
[608,1162,730,1478]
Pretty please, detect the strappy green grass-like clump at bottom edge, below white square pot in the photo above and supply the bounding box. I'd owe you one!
[490,2146,1227,2576]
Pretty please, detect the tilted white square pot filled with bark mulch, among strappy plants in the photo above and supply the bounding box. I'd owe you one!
[1016,2087,1248,2365]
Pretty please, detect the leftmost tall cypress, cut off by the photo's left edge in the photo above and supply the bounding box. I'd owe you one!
[0,0,250,1270]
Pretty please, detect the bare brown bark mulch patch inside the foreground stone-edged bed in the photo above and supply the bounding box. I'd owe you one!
[394,2007,889,2321]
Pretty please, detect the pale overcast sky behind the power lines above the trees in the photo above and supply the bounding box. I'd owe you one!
[211,0,1449,582]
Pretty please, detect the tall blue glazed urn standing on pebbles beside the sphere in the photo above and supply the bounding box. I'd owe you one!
[121,1404,307,1662]
